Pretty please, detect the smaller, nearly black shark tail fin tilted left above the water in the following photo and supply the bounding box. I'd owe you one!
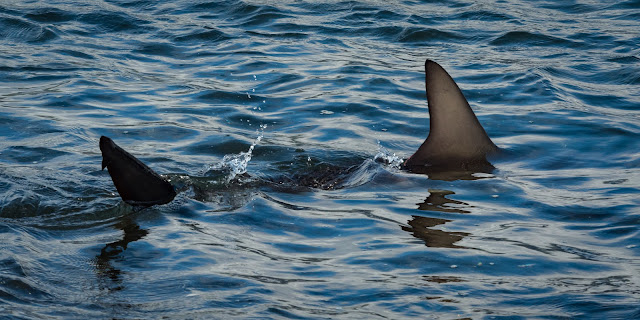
[100,136,176,206]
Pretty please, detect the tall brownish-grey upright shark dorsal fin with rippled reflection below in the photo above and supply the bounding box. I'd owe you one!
[404,60,498,170]
